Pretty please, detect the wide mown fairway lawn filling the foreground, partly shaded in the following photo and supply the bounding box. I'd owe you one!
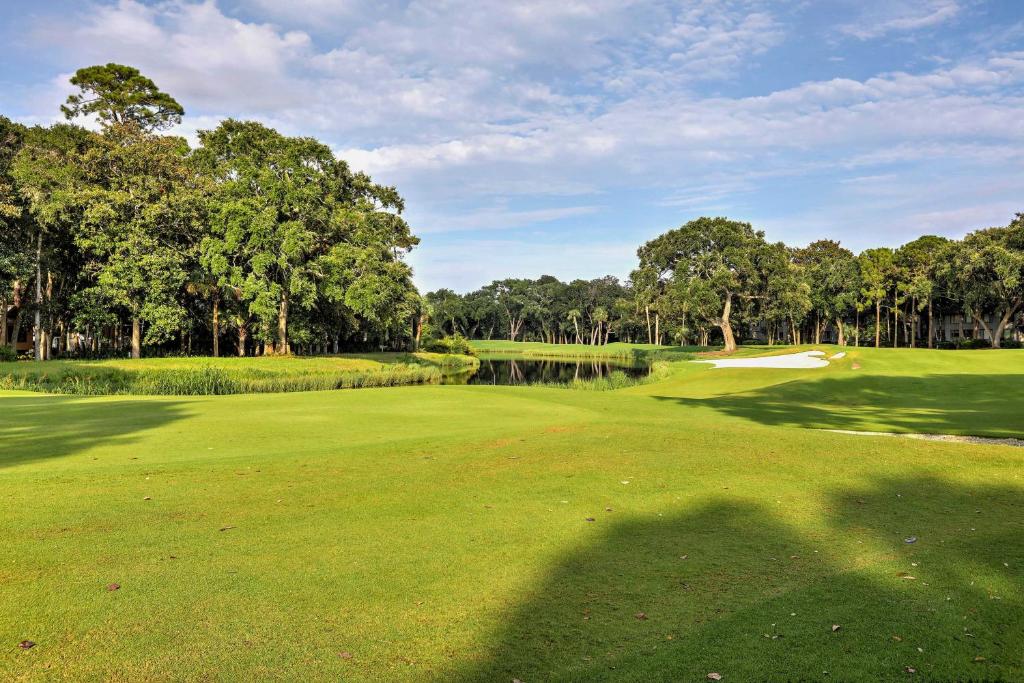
[0,348,1024,683]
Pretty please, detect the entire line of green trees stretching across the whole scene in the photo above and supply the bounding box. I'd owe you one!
[0,63,1024,359]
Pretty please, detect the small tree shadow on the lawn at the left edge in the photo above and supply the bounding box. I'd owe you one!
[0,396,186,468]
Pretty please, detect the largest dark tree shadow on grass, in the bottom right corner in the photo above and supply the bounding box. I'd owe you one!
[450,479,1024,683]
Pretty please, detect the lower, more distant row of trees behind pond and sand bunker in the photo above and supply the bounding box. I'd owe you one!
[426,214,1024,350]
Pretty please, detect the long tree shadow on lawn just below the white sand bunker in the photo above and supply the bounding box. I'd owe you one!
[656,375,1024,437]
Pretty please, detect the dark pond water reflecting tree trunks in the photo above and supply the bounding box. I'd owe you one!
[444,355,650,385]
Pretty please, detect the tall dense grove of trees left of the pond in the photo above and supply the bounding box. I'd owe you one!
[0,63,420,359]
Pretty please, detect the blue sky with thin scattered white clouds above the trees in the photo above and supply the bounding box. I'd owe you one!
[0,0,1024,291]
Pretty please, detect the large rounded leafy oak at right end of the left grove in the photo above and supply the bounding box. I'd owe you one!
[197,120,419,353]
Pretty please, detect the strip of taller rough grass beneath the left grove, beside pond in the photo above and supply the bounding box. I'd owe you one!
[0,353,478,395]
